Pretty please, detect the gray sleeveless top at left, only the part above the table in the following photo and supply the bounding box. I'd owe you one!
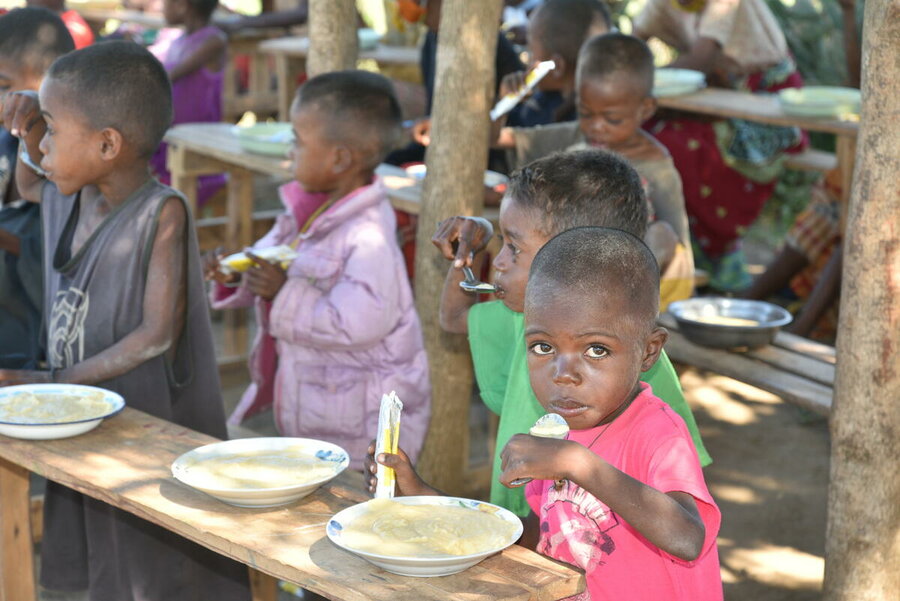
[42,179,226,438]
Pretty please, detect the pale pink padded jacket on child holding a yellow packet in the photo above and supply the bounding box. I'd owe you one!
[211,179,431,469]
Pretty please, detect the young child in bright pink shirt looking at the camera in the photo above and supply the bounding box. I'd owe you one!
[367,227,723,601]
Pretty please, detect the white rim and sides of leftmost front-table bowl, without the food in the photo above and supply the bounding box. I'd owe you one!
[0,384,125,440]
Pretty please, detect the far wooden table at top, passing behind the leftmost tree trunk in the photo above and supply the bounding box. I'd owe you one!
[259,36,419,121]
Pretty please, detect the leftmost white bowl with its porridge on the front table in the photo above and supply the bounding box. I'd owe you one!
[0,384,125,440]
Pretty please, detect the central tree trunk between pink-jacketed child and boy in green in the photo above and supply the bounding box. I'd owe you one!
[416,0,502,494]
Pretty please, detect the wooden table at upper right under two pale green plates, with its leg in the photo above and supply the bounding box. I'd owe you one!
[657,88,859,212]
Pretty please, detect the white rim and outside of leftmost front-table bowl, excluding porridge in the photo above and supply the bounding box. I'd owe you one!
[0,384,125,440]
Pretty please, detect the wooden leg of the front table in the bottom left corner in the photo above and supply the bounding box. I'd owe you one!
[0,459,37,601]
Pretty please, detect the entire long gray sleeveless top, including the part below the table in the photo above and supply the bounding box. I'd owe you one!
[40,180,250,601]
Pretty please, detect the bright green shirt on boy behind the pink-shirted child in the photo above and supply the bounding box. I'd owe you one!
[469,301,712,516]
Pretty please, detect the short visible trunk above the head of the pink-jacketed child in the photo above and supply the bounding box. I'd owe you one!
[306,0,358,77]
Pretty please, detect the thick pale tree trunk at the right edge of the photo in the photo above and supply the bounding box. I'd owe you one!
[824,0,900,601]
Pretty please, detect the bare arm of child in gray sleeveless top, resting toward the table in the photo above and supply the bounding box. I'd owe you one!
[57,198,187,384]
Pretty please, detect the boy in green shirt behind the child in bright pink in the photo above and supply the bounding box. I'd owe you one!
[432,150,712,516]
